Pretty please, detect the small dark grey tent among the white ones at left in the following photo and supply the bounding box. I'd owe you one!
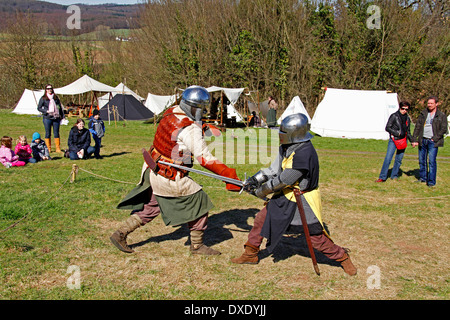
[100,94,153,121]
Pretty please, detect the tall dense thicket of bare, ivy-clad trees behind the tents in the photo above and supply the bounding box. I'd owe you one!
[131,0,450,116]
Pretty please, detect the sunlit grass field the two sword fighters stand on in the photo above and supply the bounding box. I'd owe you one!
[0,110,450,300]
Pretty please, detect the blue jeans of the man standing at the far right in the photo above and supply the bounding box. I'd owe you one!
[419,138,438,186]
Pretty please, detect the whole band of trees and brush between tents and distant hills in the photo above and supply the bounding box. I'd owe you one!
[0,0,450,119]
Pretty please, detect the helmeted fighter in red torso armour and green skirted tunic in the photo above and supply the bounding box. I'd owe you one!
[110,86,240,255]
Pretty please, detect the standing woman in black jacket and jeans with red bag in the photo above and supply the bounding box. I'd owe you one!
[375,101,412,182]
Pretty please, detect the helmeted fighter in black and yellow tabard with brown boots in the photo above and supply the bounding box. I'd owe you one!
[231,113,356,275]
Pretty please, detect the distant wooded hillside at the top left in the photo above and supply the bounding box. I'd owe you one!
[0,0,140,35]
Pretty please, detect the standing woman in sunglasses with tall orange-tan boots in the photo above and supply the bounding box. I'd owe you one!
[38,84,64,152]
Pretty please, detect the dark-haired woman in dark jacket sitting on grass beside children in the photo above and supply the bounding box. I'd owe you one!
[68,118,95,160]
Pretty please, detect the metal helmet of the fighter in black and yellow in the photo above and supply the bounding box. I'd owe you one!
[278,113,313,144]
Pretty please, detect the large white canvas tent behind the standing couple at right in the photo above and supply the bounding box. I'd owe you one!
[311,88,398,140]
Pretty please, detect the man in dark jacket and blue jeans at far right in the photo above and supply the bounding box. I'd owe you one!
[412,96,448,187]
